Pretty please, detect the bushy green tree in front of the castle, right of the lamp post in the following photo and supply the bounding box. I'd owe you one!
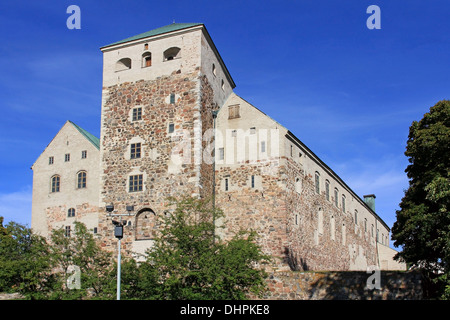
[140,198,269,300]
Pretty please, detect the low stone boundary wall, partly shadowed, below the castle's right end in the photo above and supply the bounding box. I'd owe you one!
[263,271,423,300]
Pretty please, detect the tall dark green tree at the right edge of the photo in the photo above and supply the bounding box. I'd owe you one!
[392,100,450,294]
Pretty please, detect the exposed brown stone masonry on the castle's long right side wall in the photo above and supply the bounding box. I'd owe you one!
[285,159,377,270]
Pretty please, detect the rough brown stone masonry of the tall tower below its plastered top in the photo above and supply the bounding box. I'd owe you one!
[99,71,218,253]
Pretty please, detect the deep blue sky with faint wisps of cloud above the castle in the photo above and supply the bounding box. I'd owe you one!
[0,0,450,249]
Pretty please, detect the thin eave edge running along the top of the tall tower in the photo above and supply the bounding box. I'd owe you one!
[100,23,236,89]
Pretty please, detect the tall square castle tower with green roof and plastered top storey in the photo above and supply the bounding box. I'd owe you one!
[99,23,235,253]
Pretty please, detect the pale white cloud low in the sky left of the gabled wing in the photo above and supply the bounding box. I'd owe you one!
[0,186,32,227]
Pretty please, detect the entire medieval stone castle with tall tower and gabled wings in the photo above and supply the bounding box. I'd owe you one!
[31,23,404,270]
